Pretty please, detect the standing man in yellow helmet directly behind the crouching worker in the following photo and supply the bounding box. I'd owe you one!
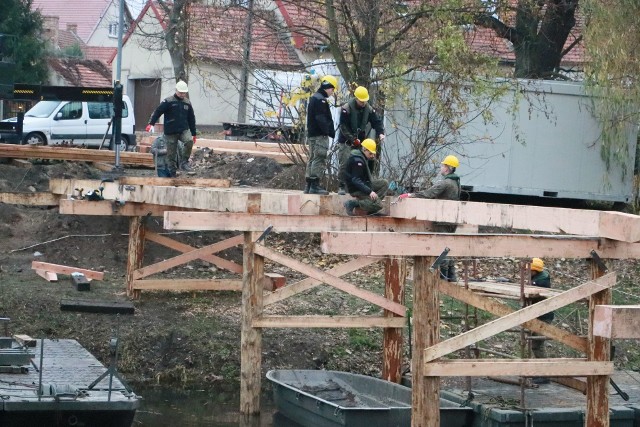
[338,86,384,195]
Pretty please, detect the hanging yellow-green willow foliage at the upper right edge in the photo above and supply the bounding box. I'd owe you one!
[581,0,640,178]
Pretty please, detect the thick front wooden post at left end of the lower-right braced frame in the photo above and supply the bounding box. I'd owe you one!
[411,256,440,427]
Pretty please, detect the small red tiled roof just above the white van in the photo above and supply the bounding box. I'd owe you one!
[47,58,113,87]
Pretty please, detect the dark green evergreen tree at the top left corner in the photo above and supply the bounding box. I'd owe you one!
[0,0,47,84]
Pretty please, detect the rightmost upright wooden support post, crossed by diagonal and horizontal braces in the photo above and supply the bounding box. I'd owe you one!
[585,259,611,427]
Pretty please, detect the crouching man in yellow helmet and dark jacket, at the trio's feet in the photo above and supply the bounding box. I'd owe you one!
[344,139,389,216]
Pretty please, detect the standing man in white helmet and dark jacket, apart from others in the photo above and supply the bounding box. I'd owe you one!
[146,80,196,177]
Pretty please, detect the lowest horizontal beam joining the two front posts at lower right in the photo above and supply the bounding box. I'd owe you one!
[424,359,614,377]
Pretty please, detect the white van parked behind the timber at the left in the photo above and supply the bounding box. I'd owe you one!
[5,95,136,151]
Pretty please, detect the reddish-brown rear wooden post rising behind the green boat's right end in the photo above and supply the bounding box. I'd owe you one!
[382,257,407,384]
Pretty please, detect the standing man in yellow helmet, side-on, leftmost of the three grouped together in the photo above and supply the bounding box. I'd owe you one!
[304,76,338,195]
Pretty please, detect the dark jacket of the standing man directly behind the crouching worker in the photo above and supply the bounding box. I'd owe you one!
[338,98,384,145]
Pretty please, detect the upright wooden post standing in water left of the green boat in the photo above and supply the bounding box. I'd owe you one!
[240,231,264,415]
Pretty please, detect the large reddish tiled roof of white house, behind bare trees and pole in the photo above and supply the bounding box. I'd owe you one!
[189,5,302,69]
